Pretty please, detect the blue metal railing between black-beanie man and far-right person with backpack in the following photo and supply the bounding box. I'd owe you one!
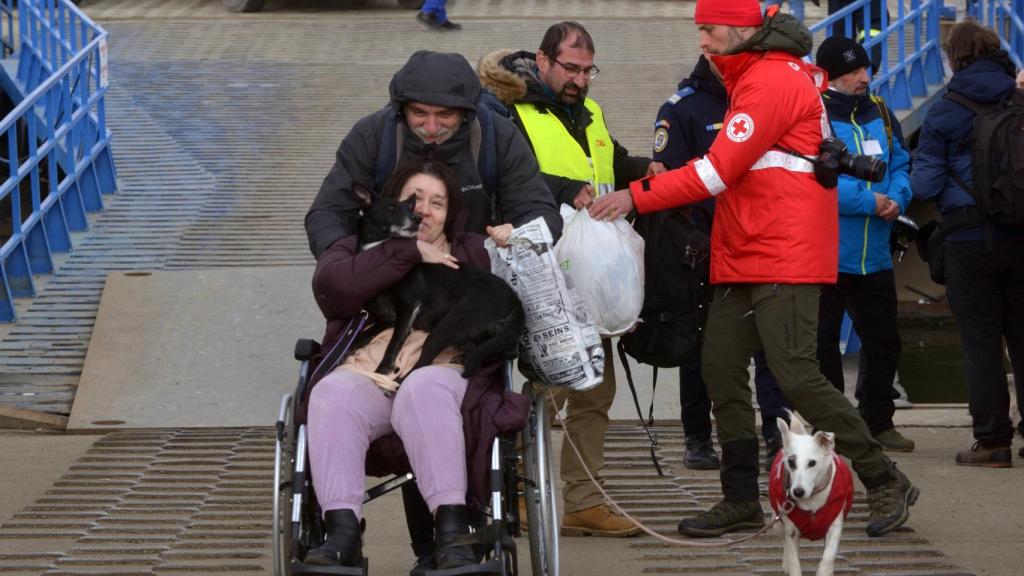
[810,0,945,110]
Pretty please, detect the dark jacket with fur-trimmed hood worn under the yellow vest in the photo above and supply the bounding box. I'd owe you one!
[477,50,651,206]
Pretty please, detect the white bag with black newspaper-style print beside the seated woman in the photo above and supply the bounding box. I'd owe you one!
[483,218,604,392]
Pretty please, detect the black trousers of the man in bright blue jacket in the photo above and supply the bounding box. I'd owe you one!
[818,270,900,435]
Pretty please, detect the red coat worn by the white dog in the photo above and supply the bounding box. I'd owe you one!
[768,450,853,540]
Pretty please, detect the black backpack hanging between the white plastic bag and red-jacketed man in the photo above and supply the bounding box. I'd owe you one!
[620,207,711,368]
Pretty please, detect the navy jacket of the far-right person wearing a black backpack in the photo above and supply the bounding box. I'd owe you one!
[910,50,1019,240]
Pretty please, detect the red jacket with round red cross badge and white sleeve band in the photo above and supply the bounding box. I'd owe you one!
[630,51,839,284]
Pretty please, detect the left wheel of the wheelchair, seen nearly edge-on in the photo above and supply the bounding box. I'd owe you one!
[272,395,295,576]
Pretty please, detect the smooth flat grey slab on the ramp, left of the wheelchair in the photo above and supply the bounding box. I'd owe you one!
[68,266,324,430]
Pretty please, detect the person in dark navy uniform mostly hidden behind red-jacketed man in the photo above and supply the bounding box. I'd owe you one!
[640,52,790,470]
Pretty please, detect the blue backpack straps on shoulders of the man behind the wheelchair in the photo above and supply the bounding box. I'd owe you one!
[374,89,512,222]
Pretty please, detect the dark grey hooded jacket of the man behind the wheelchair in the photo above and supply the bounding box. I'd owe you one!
[305,50,562,258]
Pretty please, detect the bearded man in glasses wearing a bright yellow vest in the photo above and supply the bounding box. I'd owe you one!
[478,22,665,537]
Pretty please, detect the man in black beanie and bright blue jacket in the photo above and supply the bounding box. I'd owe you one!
[815,36,914,452]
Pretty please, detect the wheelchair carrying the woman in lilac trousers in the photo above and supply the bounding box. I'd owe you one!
[272,314,559,576]
